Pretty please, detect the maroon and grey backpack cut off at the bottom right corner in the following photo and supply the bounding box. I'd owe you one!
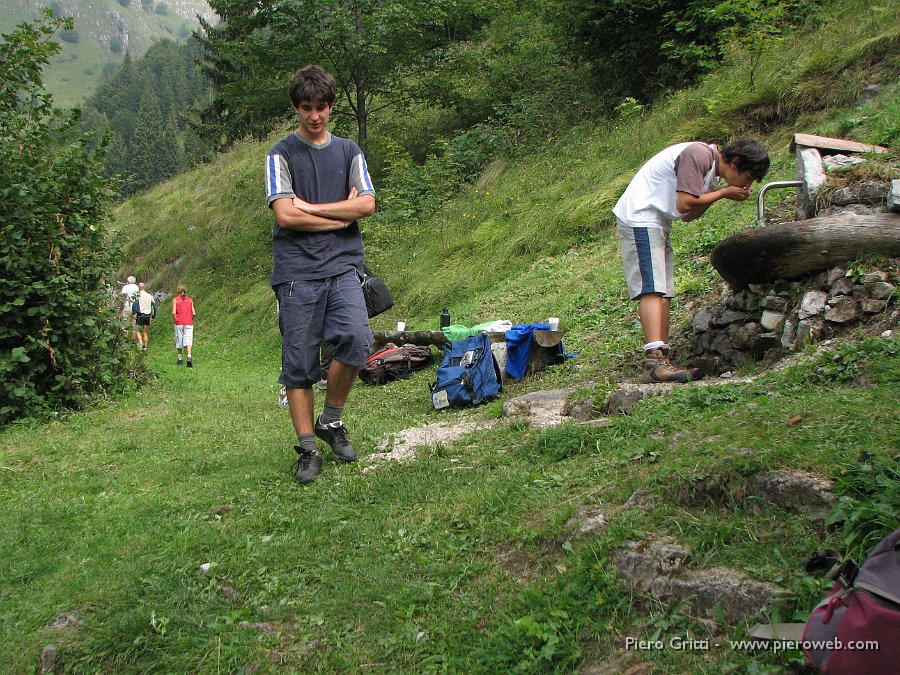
[803,529,900,675]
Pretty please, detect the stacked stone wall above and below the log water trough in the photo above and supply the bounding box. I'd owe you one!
[673,156,900,375]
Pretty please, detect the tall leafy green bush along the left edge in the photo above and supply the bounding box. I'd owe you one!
[0,10,125,424]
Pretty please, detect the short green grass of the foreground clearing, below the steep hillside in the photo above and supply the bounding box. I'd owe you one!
[0,336,900,672]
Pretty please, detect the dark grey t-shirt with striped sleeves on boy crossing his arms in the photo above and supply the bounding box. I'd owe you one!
[266,132,375,286]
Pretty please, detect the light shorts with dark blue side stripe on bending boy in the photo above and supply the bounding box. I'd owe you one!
[617,220,675,300]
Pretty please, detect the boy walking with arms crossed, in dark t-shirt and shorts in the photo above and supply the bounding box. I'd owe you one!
[265,65,375,483]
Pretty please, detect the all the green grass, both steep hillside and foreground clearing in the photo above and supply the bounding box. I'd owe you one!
[0,2,900,672]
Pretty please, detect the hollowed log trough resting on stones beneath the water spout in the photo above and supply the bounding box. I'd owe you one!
[710,213,900,291]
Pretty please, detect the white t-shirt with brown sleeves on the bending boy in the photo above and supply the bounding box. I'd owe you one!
[613,141,719,230]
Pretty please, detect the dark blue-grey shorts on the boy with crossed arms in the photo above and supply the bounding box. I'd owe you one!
[273,270,372,389]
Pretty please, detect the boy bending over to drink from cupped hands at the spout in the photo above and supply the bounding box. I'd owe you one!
[613,138,769,382]
